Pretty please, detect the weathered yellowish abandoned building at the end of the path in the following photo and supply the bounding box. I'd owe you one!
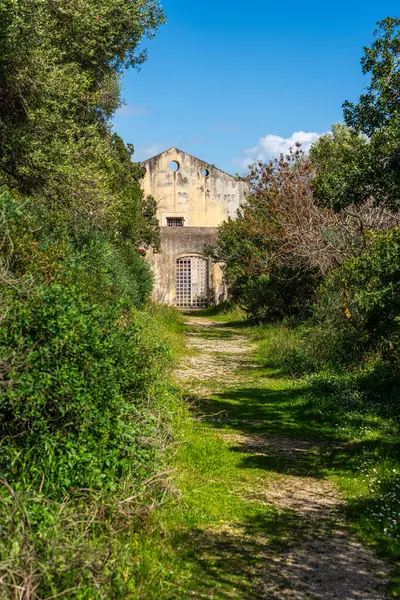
[141,148,247,308]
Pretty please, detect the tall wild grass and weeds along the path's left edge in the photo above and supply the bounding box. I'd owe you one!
[0,306,185,600]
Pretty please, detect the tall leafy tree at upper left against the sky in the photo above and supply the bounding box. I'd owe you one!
[0,0,164,246]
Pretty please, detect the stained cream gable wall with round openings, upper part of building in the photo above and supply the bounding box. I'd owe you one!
[142,148,247,227]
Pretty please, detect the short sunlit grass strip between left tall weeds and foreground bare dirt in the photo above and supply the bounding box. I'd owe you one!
[146,406,310,600]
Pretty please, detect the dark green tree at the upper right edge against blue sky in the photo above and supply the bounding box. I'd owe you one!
[311,17,400,211]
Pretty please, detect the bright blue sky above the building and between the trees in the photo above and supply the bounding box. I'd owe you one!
[114,0,400,173]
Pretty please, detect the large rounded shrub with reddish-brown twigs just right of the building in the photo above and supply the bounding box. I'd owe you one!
[215,143,397,318]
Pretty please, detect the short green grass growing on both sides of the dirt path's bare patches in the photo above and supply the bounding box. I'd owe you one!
[143,312,400,600]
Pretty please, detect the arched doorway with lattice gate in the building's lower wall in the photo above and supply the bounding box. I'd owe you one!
[176,255,209,308]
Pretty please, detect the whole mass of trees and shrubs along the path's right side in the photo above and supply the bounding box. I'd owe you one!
[214,18,400,393]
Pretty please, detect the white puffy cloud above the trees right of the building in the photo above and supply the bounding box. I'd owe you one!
[232,131,323,169]
